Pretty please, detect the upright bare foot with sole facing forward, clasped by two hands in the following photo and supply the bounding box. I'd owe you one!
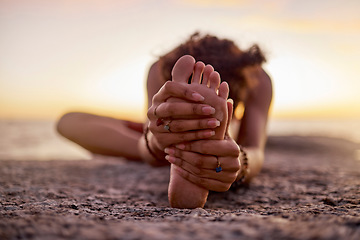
[168,55,229,208]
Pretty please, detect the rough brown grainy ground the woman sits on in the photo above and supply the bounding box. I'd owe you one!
[0,136,360,240]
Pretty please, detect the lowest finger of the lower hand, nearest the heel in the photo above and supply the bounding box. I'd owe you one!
[173,165,232,192]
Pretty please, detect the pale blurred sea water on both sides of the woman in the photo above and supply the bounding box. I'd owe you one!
[0,119,360,161]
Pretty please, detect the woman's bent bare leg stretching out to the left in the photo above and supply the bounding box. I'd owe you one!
[57,112,142,161]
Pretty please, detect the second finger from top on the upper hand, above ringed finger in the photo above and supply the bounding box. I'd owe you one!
[148,102,215,118]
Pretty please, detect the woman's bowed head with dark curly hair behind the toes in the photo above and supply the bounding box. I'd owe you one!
[159,33,265,107]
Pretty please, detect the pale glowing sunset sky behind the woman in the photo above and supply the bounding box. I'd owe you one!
[0,0,360,120]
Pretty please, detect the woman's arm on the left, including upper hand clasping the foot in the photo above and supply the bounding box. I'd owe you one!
[138,63,222,166]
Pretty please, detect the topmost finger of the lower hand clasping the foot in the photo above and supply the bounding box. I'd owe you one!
[176,138,240,157]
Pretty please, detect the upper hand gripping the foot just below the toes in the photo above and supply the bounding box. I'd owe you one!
[147,81,220,151]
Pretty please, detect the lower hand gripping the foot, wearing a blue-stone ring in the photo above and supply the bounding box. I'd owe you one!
[165,136,241,192]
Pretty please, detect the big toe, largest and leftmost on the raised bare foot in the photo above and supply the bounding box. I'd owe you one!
[171,55,195,83]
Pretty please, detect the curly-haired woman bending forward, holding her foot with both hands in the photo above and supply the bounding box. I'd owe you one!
[58,33,272,208]
